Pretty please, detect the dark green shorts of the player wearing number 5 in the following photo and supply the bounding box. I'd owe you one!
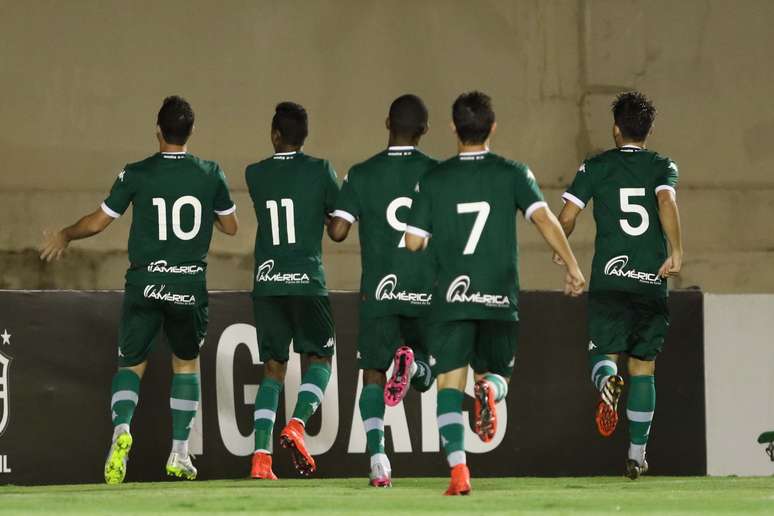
[589,291,669,360]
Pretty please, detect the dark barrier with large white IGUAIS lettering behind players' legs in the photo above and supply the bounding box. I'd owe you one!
[0,291,706,484]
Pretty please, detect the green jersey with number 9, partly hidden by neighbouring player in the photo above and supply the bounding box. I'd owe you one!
[333,147,438,317]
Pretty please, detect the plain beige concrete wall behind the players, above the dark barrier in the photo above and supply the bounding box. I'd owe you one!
[0,0,774,292]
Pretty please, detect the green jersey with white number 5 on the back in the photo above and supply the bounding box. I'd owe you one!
[562,145,678,297]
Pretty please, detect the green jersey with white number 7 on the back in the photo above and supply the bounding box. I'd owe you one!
[406,151,546,321]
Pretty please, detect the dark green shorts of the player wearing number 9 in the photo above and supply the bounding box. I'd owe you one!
[357,315,428,371]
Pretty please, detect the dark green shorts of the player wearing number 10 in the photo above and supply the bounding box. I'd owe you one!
[118,282,208,367]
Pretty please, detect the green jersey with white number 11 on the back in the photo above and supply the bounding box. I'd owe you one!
[245,152,339,296]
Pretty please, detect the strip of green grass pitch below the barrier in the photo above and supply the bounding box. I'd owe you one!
[0,477,774,515]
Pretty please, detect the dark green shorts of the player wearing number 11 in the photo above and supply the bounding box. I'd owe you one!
[253,296,336,363]
